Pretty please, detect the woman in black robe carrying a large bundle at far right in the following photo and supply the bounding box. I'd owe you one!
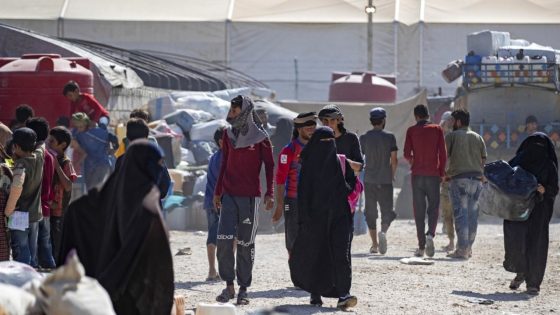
[504,132,558,295]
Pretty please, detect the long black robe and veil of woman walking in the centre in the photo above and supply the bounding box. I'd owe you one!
[289,127,356,298]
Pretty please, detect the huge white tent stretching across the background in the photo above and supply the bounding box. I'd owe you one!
[0,0,560,100]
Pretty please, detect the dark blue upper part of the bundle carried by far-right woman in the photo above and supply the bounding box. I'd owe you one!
[484,161,538,198]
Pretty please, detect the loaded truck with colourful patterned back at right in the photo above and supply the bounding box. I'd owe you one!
[442,31,560,216]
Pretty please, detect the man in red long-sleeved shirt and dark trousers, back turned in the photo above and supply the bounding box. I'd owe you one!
[404,105,447,257]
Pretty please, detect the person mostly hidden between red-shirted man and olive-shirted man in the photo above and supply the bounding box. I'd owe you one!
[439,111,455,252]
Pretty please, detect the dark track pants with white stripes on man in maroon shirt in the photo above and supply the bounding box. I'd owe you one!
[217,195,260,287]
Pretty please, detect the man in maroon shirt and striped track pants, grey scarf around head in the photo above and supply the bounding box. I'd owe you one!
[214,95,274,305]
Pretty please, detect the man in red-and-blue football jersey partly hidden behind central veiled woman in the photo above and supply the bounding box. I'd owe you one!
[272,112,317,253]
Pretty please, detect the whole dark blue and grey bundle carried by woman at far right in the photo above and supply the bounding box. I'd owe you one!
[478,161,538,221]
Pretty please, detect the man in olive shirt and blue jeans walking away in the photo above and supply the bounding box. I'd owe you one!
[445,109,486,259]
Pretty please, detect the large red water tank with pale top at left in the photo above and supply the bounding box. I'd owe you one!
[0,54,93,126]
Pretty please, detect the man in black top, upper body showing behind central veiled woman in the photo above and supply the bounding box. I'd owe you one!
[319,104,364,172]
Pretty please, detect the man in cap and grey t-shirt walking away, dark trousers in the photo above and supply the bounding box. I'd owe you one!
[360,107,398,254]
